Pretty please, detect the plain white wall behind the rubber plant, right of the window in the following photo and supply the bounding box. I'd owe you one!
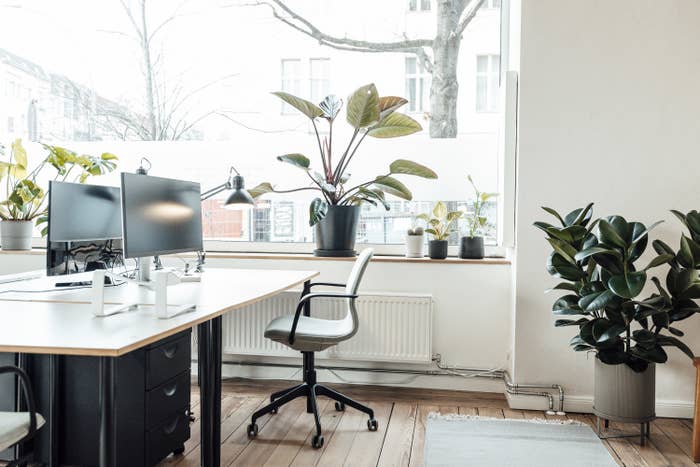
[514,0,700,415]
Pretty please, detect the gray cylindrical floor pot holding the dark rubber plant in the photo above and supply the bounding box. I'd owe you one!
[593,358,656,423]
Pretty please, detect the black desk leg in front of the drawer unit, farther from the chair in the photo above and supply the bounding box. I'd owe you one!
[99,357,117,467]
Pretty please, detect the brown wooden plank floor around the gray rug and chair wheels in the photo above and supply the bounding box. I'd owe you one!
[154,380,700,467]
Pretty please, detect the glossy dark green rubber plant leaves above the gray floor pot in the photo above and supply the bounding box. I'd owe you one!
[534,203,700,372]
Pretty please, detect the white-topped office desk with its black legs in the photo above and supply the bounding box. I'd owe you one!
[0,269,318,467]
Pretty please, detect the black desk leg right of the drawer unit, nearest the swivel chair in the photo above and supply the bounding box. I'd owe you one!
[197,316,221,467]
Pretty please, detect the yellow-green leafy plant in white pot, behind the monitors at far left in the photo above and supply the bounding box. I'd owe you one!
[0,139,117,250]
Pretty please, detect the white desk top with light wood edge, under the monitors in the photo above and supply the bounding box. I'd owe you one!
[0,268,318,357]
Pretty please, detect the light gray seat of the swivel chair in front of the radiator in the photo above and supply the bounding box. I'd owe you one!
[265,315,353,352]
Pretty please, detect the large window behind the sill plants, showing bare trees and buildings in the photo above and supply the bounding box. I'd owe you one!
[0,0,502,254]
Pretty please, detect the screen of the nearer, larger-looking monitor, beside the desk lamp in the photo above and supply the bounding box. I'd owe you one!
[122,173,202,258]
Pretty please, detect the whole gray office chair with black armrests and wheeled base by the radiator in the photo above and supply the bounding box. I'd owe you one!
[248,249,379,449]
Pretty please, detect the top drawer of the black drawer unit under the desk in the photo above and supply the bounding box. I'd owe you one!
[146,332,192,389]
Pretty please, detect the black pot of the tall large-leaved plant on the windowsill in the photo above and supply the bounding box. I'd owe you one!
[314,206,360,257]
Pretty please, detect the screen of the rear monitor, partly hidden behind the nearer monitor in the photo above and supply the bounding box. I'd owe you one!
[48,181,122,242]
